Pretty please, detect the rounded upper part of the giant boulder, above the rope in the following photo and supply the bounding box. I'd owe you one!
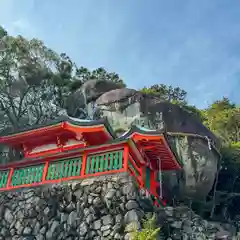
[95,88,217,143]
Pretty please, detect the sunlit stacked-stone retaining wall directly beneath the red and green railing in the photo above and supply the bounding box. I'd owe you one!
[0,174,154,240]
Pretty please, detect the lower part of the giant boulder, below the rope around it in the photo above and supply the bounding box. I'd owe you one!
[164,136,219,200]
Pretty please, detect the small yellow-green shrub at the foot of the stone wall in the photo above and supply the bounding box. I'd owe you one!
[126,214,160,240]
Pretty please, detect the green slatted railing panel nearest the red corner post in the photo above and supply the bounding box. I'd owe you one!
[85,150,123,174]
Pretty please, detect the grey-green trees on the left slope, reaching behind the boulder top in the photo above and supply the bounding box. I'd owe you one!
[0,27,124,131]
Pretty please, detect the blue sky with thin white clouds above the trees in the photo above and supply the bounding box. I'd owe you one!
[0,0,240,107]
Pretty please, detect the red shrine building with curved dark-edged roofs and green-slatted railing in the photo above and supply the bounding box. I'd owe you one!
[0,117,181,204]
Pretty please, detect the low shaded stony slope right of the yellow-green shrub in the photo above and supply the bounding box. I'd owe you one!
[156,206,236,240]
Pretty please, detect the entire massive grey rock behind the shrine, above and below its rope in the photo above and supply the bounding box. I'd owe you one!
[65,81,219,198]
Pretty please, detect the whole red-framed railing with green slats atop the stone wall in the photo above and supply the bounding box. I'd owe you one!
[0,146,146,191]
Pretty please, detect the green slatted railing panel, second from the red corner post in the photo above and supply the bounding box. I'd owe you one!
[46,157,82,180]
